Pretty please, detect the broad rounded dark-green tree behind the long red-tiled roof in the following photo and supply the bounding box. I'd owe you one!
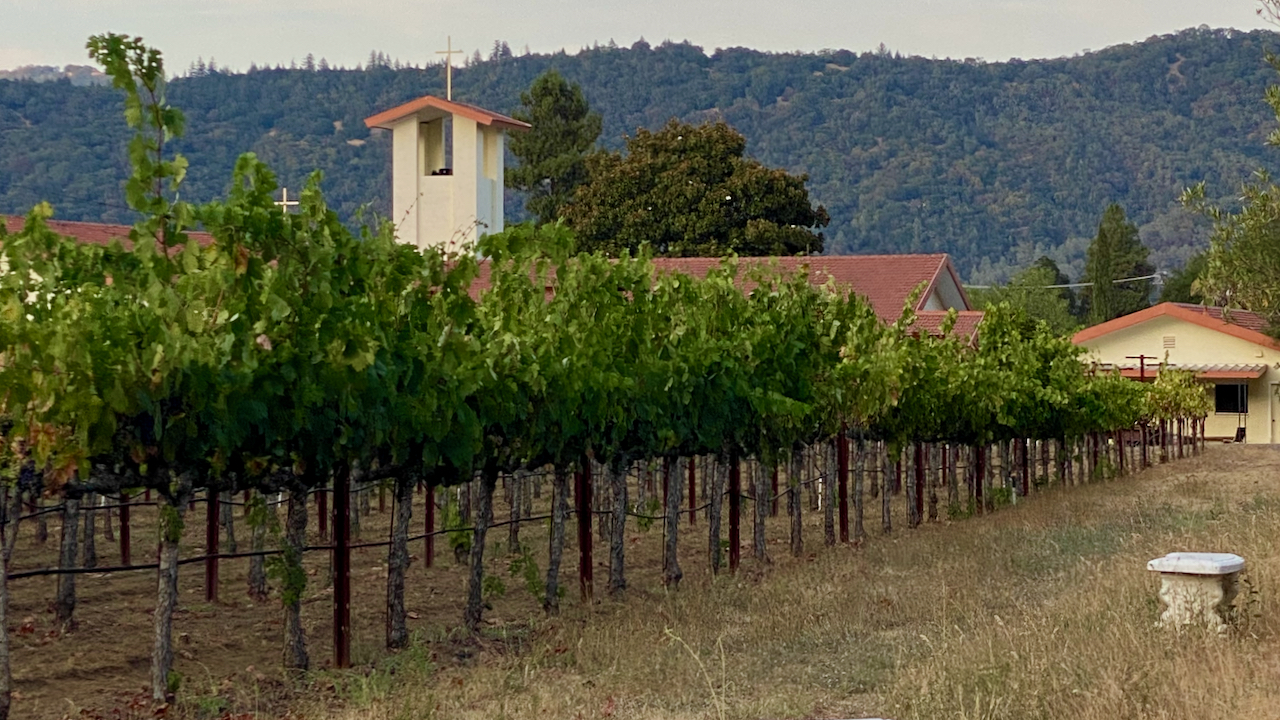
[564,119,829,258]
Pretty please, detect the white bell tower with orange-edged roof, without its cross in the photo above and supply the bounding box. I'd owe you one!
[365,95,530,251]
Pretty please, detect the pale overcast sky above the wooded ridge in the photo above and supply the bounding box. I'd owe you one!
[0,0,1270,72]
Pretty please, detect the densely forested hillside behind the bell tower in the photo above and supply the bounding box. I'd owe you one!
[0,27,1280,282]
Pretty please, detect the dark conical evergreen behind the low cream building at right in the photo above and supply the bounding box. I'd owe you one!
[1083,202,1155,324]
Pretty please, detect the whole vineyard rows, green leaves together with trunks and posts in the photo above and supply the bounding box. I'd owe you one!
[0,36,1208,715]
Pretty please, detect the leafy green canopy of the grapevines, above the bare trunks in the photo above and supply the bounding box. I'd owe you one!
[0,36,1207,504]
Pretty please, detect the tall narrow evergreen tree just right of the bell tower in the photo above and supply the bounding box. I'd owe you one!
[507,70,602,223]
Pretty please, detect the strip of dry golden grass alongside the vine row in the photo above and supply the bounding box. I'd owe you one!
[312,447,1280,720]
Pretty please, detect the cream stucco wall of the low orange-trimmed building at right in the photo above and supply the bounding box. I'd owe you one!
[1080,316,1280,443]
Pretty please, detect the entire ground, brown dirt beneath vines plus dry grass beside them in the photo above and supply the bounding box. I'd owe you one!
[14,446,1280,720]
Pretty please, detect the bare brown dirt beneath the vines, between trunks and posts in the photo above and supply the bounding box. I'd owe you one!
[10,461,829,719]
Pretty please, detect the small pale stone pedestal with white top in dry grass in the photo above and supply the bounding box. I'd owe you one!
[1147,552,1244,633]
